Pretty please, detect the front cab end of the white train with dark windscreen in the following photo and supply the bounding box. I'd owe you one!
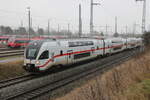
[23,42,50,72]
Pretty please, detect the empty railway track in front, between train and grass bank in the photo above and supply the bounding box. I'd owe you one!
[2,48,141,100]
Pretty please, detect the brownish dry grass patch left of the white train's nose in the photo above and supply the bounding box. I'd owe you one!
[0,61,25,80]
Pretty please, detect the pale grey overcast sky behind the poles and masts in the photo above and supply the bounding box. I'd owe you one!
[0,0,150,33]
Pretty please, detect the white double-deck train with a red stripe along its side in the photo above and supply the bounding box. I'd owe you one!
[23,38,143,72]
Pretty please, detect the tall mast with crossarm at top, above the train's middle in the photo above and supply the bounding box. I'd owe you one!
[90,0,100,34]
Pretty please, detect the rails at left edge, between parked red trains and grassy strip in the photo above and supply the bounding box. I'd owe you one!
[0,49,24,57]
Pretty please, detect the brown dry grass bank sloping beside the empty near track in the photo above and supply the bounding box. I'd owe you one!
[57,51,150,100]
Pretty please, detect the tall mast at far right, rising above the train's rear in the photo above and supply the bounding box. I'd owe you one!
[136,0,146,33]
